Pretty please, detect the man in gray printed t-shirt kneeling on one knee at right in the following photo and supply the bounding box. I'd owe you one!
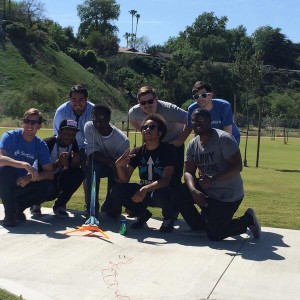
[178,108,261,241]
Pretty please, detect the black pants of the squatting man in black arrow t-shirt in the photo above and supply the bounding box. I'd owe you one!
[111,183,175,219]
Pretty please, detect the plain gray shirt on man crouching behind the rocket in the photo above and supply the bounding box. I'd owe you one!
[84,121,129,159]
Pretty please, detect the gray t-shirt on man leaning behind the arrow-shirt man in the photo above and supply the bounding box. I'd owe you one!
[128,100,187,143]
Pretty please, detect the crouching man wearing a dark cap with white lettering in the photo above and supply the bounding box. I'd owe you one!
[30,120,84,217]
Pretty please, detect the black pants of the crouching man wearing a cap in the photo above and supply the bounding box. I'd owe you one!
[49,168,84,207]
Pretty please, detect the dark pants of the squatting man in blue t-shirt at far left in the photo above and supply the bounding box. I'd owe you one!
[0,167,54,215]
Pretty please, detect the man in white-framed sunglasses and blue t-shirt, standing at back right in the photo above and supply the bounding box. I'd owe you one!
[179,81,240,144]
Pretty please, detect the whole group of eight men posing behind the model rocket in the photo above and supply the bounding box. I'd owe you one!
[0,81,261,240]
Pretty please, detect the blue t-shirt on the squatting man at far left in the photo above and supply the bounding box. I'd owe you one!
[0,129,51,177]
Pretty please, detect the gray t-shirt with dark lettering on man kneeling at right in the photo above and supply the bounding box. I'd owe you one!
[185,129,244,202]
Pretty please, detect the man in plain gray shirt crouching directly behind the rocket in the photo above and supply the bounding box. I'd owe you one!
[84,104,129,218]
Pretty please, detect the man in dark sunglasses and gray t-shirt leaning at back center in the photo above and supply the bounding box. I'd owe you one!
[129,86,187,184]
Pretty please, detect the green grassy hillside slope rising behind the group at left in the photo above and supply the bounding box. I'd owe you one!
[0,39,127,125]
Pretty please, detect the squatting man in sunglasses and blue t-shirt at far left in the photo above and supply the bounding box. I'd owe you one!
[0,108,53,227]
